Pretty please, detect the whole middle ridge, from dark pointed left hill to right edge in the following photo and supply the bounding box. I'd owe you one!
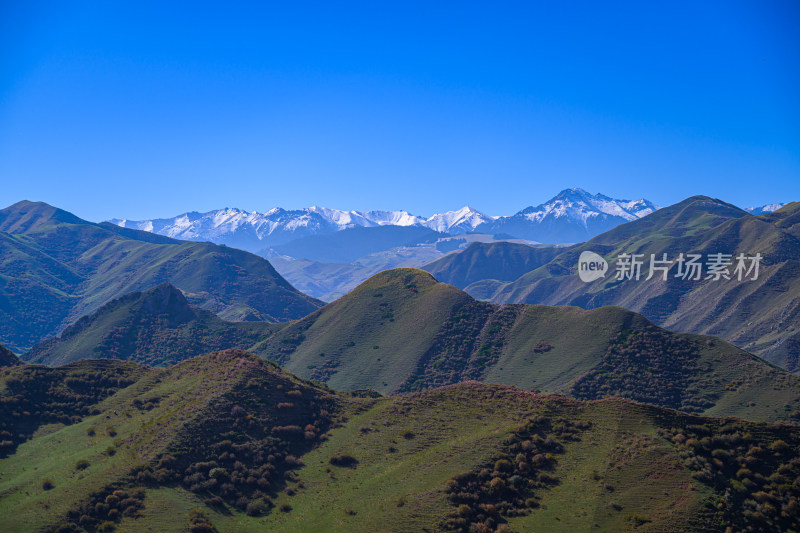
[15,269,800,420]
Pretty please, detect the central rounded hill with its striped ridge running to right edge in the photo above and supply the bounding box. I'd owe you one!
[252,269,800,420]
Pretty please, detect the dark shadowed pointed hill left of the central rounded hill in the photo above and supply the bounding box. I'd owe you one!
[23,283,279,366]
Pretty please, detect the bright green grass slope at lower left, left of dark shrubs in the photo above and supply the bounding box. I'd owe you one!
[0,353,338,531]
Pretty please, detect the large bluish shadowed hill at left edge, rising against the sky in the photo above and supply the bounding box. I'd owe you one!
[0,202,320,352]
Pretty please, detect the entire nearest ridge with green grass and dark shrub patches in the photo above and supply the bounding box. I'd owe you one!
[0,351,800,533]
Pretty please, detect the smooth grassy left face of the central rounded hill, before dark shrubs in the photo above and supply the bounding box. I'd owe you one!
[254,269,470,391]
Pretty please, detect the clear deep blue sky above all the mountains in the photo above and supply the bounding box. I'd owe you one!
[0,0,800,220]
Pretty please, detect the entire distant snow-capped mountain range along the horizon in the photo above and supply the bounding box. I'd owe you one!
[110,188,782,252]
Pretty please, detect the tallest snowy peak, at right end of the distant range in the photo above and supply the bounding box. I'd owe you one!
[476,188,658,243]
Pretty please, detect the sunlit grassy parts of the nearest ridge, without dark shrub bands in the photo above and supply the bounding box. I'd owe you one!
[6,356,800,532]
